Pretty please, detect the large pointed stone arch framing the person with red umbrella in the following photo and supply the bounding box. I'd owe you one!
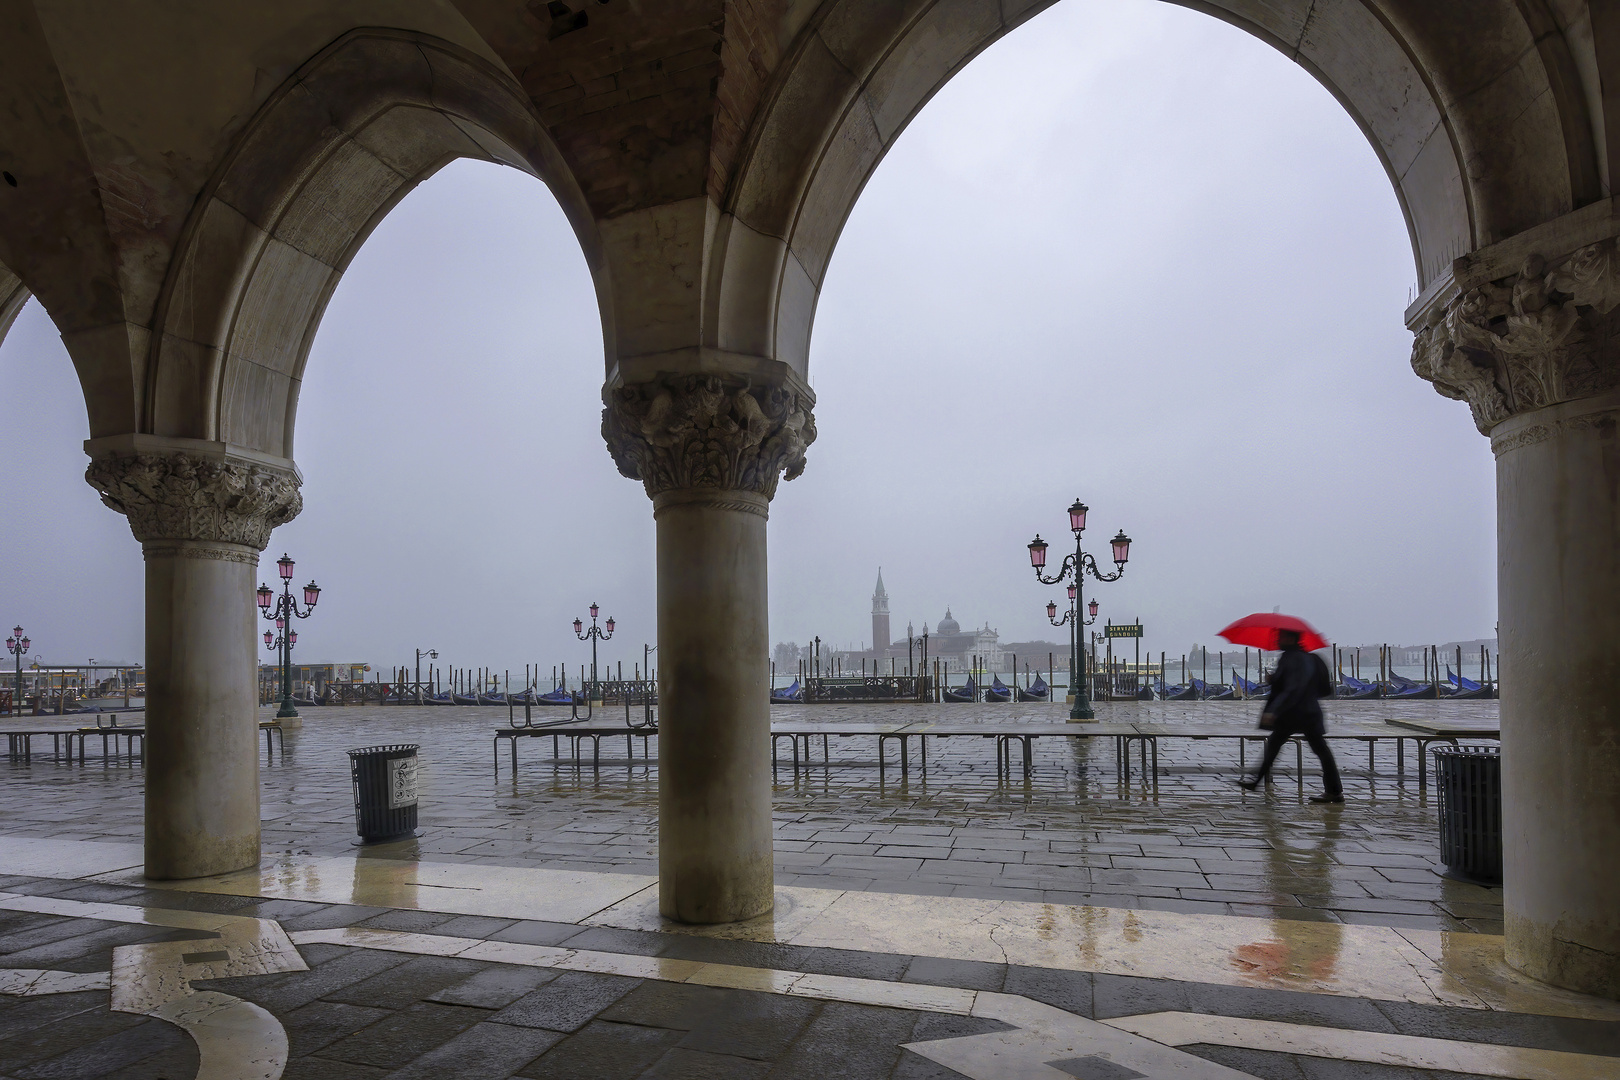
[710,0,1605,374]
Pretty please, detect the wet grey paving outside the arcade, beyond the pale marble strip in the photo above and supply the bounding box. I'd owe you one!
[0,701,1502,933]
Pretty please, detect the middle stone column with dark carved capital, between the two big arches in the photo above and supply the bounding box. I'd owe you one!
[603,374,815,923]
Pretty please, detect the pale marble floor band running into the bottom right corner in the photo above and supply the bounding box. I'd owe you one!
[1105,1012,1620,1080]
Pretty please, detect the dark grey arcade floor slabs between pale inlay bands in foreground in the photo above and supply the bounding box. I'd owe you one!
[0,878,1581,1080]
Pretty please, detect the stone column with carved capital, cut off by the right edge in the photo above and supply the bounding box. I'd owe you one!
[1413,234,1620,997]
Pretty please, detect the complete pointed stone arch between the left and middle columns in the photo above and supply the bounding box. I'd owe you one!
[138,29,612,458]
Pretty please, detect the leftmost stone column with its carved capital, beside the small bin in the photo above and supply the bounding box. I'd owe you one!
[84,436,303,879]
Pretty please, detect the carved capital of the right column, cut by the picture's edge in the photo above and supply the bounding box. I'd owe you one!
[1413,240,1620,434]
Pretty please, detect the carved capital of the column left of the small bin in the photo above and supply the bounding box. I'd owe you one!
[84,452,303,551]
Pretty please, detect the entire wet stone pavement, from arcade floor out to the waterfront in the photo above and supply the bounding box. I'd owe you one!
[0,703,1620,1080]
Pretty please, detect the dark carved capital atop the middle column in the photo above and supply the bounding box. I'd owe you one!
[603,374,815,499]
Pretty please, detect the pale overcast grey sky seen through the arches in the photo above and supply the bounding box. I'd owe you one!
[0,0,1495,674]
